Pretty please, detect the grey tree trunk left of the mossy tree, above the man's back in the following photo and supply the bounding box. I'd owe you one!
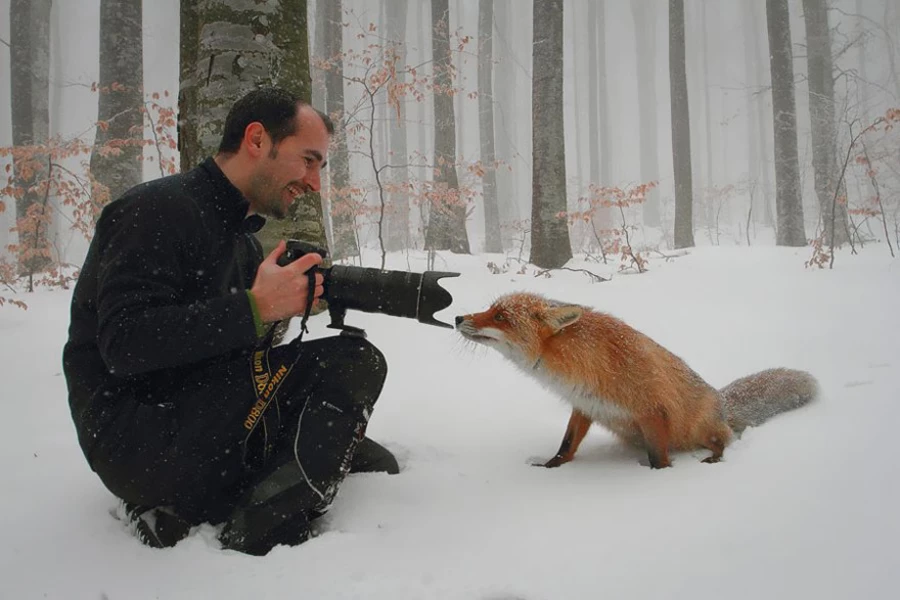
[91,0,144,205]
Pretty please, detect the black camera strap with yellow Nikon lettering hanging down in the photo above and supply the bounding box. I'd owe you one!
[243,267,316,463]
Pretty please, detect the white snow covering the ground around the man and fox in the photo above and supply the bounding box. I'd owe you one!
[0,245,900,600]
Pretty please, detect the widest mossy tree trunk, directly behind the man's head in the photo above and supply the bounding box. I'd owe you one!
[179,0,328,251]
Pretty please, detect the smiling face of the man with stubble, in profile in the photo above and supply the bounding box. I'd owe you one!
[247,106,330,219]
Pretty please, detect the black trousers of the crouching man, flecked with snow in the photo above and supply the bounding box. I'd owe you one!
[92,336,397,543]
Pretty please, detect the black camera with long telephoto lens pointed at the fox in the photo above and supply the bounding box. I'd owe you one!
[278,240,459,333]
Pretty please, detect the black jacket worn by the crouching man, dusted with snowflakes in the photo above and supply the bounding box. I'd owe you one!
[63,158,262,462]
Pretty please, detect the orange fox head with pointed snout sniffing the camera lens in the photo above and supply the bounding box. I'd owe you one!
[456,293,584,363]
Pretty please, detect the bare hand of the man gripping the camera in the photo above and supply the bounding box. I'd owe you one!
[250,240,324,323]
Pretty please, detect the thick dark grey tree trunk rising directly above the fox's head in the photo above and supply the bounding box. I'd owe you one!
[530,0,572,268]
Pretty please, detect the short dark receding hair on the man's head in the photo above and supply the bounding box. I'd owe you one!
[219,87,334,154]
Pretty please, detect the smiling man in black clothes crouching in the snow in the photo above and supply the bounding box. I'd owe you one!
[63,88,398,555]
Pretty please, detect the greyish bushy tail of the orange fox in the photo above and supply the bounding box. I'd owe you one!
[719,368,819,435]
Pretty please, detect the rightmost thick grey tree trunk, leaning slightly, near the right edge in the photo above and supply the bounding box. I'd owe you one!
[803,0,849,246]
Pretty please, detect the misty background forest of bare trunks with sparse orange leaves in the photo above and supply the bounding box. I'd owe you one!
[0,0,900,301]
